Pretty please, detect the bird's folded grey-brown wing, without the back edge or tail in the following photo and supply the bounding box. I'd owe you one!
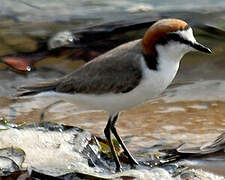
[56,50,142,94]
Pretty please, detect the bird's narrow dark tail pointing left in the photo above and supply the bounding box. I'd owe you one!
[15,80,59,97]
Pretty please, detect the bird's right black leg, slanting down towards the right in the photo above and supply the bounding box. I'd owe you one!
[110,113,138,168]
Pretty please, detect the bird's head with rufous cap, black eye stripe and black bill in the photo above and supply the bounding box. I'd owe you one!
[142,19,211,61]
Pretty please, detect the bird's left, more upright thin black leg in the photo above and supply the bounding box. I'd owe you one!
[104,116,122,172]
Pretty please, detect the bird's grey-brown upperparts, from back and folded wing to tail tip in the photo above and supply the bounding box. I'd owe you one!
[19,42,142,96]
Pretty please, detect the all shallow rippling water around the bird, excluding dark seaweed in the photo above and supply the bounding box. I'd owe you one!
[0,0,225,179]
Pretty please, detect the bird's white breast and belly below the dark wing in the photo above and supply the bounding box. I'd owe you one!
[38,57,179,114]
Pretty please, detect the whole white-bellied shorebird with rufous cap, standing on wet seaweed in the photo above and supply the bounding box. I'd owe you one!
[17,18,212,172]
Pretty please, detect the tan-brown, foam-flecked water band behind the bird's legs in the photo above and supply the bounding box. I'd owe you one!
[7,83,225,151]
